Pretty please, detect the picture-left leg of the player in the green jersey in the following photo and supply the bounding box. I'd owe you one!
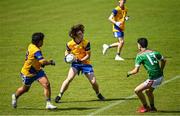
[134,82,149,113]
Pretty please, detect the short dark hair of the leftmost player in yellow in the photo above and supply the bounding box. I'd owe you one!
[32,32,44,45]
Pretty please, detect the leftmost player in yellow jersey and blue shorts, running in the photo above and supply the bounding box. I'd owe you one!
[12,33,57,109]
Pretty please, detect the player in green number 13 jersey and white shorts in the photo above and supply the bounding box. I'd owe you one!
[127,38,166,113]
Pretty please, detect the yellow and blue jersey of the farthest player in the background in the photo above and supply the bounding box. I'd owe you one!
[112,6,127,32]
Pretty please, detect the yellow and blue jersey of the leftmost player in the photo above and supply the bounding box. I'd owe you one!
[21,44,45,77]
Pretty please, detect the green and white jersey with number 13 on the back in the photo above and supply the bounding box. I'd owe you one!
[135,50,163,79]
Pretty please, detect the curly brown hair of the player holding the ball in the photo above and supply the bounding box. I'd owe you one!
[69,24,84,39]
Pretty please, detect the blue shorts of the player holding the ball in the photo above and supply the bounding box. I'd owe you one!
[71,63,94,74]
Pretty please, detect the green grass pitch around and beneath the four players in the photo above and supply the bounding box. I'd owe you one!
[0,0,180,115]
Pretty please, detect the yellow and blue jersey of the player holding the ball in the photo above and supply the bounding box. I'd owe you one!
[66,39,90,64]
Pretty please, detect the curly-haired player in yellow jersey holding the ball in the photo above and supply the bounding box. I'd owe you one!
[55,24,105,103]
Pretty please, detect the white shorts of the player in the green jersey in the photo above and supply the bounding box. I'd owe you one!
[144,76,163,88]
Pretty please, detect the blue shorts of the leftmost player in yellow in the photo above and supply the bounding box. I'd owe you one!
[20,70,46,86]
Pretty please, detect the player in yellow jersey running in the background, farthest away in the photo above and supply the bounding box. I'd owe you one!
[102,0,128,61]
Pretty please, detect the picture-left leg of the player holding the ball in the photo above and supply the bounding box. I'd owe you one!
[55,67,78,103]
